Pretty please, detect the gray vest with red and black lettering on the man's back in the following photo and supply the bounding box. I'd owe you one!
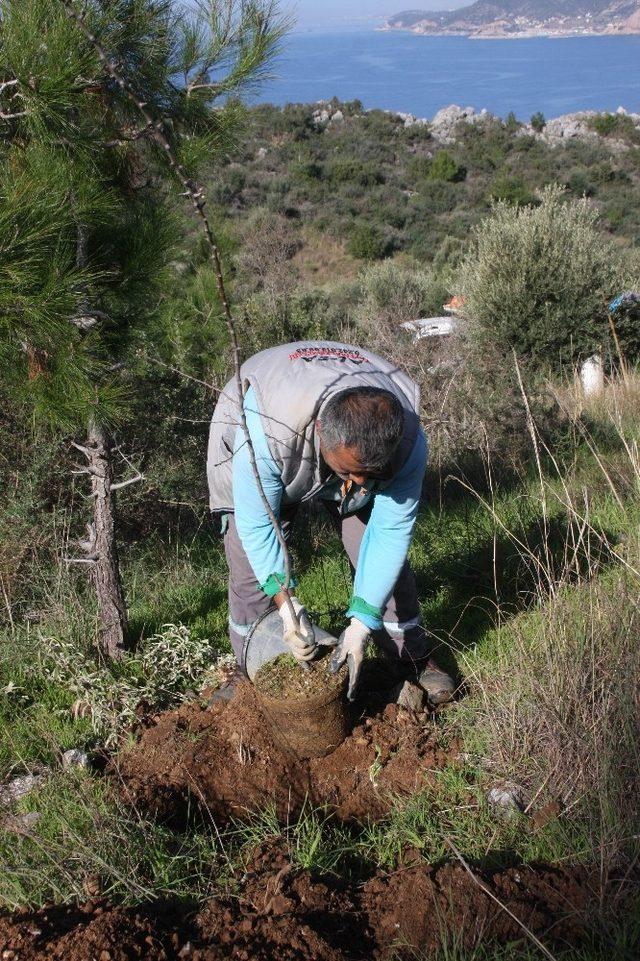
[207,340,420,511]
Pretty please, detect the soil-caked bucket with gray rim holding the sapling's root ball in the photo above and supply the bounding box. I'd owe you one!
[243,611,351,758]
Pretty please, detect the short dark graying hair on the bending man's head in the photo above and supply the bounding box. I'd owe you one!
[320,387,404,472]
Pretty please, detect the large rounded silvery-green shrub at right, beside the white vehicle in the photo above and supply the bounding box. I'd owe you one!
[459,186,640,367]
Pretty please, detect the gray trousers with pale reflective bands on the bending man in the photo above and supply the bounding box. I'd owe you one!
[224,503,428,664]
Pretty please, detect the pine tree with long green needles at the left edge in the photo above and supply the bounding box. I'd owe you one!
[0,0,284,656]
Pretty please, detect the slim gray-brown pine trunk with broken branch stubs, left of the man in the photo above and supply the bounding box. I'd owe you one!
[87,424,127,658]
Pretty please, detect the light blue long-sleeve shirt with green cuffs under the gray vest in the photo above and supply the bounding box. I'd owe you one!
[233,388,427,630]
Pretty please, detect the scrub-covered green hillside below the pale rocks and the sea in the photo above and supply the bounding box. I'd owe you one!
[213,102,640,281]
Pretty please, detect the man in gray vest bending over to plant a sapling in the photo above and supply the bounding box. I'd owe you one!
[207,341,454,704]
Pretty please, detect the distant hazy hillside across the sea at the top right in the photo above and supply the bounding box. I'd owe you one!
[387,0,640,37]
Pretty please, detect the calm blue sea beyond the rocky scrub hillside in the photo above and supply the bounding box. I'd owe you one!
[257,24,640,120]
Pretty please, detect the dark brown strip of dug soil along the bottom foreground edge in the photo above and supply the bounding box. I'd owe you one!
[0,847,594,961]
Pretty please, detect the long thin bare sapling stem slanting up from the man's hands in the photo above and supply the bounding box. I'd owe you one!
[62,0,299,625]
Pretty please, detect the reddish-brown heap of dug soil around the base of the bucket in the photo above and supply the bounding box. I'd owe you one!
[118,684,457,824]
